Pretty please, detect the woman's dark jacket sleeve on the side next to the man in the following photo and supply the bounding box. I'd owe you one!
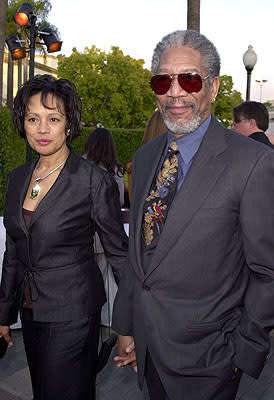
[92,172,128,283]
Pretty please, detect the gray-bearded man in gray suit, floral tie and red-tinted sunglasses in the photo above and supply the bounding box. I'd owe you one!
[113,30,274,400]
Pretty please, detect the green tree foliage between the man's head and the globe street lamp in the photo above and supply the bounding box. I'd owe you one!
[211,75,243,127]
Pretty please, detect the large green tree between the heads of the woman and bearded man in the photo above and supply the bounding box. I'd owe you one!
[58,46,155,128]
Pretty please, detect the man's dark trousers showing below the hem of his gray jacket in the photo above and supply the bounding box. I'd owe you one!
[145,352,242,400]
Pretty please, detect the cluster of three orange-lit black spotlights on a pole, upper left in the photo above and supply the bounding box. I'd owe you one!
[6,3,62,161]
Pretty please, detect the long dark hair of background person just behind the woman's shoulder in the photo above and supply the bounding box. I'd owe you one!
[84,128,124,176]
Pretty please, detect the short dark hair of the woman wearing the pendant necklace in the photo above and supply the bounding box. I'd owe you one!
[13,75,82,142]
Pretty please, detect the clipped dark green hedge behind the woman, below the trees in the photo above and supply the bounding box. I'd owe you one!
[0,107,144,215]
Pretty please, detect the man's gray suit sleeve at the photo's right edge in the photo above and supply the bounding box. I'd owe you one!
[234,151,274,377]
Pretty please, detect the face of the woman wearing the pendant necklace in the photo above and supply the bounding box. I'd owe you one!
[24,93,67,156]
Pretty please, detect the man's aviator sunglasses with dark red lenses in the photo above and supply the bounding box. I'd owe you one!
[150,72,209,94]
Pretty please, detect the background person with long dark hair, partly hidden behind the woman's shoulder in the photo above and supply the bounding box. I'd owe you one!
[83,128,125,326]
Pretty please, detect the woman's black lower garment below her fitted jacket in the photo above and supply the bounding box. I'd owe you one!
[22,309,100,400]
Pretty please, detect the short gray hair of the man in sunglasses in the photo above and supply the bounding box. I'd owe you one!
[151,30,221,81]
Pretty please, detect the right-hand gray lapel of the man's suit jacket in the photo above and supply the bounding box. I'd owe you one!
[147,118,229,276]
